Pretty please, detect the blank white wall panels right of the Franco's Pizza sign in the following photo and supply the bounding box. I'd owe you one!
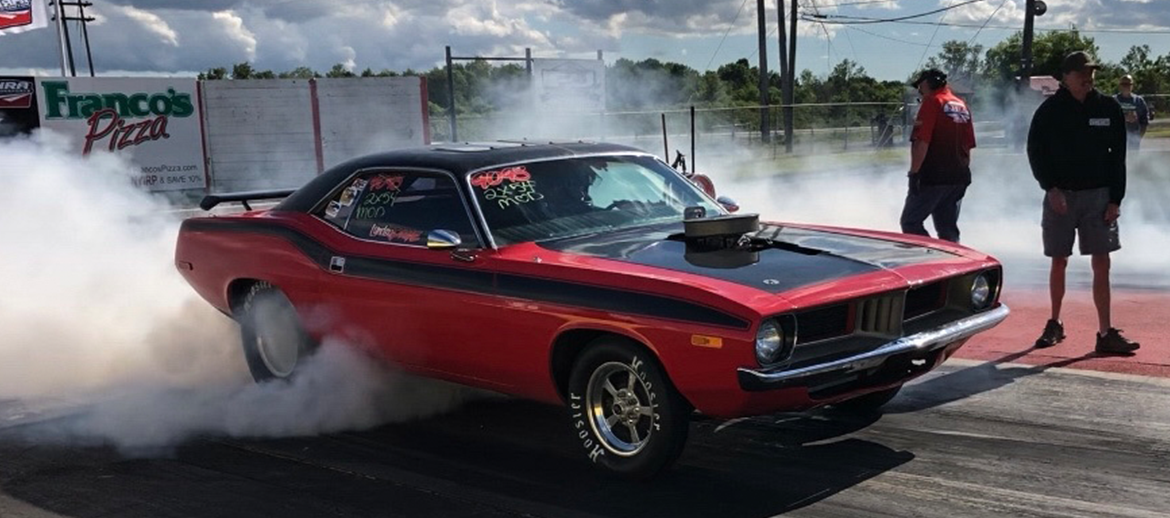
[202,77,429,192]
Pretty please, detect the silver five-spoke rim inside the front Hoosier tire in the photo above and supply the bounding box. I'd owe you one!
[585,361,655,456]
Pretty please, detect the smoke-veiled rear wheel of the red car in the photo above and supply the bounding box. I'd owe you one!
[238,282,314,381]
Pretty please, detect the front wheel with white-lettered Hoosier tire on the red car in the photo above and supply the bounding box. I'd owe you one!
[569,337,691,478]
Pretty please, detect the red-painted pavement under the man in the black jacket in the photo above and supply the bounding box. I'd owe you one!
[956,288,1170,378]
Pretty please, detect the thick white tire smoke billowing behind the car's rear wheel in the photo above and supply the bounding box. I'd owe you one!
[0,132,473,451]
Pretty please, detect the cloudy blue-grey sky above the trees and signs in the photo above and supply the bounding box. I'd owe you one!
[0,0,1170,74]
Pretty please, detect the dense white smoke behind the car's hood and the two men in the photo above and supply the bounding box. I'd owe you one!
[698,131,1170,289]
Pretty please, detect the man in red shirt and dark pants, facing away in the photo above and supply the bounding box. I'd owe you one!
[901,69,975,243]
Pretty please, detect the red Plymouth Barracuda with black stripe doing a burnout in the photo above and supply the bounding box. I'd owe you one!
[176,143,1009,477]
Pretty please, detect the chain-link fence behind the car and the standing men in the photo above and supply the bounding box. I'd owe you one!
[431,94,1170,159]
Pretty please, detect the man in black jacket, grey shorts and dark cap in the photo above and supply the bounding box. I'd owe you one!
[1027,51,1138,354]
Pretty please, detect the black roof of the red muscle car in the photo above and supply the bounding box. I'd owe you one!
[274,140,646,212]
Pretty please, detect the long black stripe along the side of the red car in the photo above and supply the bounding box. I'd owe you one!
[183,220,750,329]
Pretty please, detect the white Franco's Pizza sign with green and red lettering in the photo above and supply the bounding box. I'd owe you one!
[34,78,207,191]
